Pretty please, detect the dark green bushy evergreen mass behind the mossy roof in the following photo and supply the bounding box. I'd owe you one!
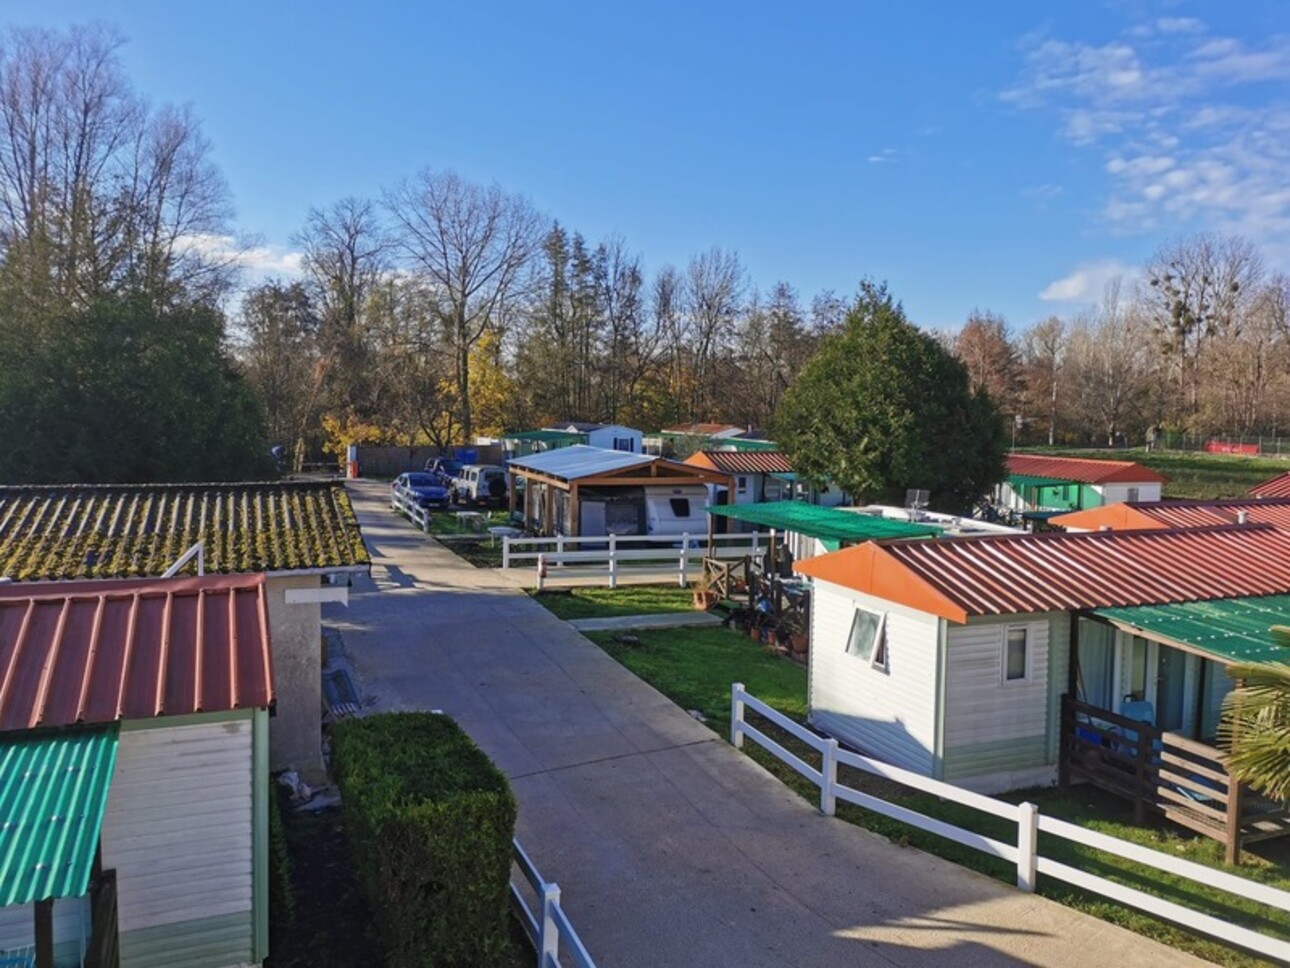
[0,296,273,484]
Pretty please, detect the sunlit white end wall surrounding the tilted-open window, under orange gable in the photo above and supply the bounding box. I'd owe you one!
[808,580,940,776]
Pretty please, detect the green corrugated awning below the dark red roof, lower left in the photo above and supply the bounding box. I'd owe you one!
[0,727,117,907]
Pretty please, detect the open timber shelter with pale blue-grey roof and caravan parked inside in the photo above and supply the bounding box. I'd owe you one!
[507,445,730,536]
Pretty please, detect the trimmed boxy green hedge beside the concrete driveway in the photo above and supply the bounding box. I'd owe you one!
[332,712,515,968]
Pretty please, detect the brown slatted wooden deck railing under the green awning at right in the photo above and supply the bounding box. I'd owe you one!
[1060,696,1290,863]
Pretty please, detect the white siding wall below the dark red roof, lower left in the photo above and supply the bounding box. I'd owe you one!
[102,712,253,967]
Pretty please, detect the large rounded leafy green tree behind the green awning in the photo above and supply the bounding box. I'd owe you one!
[774,283,1005,511]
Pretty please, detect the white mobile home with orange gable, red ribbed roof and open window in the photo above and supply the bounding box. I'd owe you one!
[797,527,1290,862]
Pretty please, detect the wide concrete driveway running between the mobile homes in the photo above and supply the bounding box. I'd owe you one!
[325,483,1201,968]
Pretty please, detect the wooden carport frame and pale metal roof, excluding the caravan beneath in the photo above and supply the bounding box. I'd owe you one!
[507,444,730,536]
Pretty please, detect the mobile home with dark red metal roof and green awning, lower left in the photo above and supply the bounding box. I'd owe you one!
[0,574,273,968]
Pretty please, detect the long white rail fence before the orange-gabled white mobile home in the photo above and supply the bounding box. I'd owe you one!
[730,683,1290,963]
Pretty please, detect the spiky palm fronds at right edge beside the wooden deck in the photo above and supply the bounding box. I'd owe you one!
[1219,660,1290,800]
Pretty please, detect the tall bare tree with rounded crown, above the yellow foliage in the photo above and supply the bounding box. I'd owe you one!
[386,169,543,439]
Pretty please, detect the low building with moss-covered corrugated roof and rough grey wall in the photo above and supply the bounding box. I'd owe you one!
[0,481,372,782]
